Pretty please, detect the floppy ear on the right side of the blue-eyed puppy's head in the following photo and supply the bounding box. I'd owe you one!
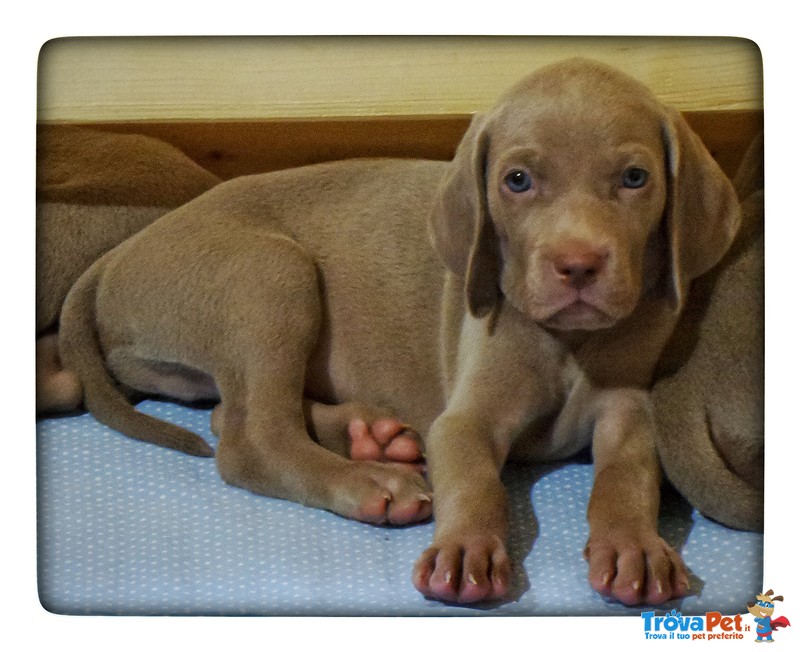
[663,109,741,309]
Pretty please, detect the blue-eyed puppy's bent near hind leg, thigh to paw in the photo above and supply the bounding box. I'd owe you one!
[214,236,431,524]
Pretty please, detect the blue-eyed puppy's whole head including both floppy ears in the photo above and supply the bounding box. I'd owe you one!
[431,60,739,330]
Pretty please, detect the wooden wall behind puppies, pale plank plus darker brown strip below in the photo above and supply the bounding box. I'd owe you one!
[38,37,763,178]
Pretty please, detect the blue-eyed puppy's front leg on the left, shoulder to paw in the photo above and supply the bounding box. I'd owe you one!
[413,313,552,603]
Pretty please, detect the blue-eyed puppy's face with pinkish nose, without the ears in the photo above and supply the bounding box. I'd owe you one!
[485,77,667,330]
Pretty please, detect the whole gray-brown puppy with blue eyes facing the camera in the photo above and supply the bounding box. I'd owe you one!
[61,60,739,604]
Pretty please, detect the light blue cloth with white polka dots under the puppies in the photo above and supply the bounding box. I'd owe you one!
[37,401,762,616]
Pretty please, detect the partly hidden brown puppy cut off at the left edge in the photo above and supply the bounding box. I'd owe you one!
[36,125,220,413]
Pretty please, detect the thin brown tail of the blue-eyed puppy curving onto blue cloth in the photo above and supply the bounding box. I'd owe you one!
[59,256,214,457]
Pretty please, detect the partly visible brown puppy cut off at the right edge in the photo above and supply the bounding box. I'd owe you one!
[652,134,764,530]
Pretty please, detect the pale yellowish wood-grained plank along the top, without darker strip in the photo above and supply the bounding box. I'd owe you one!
[38,37,762,122]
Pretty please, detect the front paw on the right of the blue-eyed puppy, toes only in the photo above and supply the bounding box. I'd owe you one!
[584,530,689,605]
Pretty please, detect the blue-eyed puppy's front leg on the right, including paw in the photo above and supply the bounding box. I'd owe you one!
[585,389,689,605]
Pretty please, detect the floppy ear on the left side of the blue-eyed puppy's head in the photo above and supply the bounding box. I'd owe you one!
[429,116,500,317]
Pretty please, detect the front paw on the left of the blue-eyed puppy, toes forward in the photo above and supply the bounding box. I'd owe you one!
[412,535,511,604]
